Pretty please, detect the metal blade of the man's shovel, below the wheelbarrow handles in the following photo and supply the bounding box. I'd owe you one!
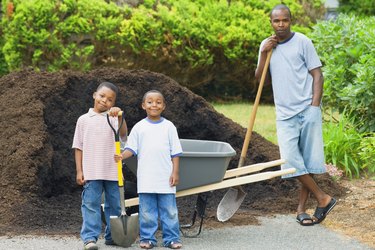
[216,186,246,222]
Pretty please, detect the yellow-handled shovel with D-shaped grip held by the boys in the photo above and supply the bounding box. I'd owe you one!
[107,112,139,247]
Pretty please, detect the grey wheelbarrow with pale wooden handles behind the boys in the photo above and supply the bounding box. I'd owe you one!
[125,139,296,236]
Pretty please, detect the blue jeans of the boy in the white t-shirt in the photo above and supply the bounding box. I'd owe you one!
[139,193,180,245]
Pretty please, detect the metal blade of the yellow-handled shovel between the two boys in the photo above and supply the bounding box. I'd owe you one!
[110,214,139,247]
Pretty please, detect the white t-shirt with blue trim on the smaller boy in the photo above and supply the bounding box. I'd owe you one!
[125,117,182,193]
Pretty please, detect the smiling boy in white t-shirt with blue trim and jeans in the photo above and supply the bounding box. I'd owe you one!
[115,90,182,249]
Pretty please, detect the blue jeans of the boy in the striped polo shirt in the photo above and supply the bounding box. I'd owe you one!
[81,180,121,242]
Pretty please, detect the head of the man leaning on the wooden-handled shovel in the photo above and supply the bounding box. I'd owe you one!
[270,9,292,41]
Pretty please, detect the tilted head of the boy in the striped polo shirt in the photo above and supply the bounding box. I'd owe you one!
[93,82,118,113]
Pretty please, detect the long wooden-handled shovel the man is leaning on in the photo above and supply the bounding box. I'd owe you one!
[216,50,272,221]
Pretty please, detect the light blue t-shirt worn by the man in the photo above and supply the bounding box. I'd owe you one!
[258,32,322,120]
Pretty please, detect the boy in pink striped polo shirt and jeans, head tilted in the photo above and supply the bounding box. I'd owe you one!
[72,82,127,250]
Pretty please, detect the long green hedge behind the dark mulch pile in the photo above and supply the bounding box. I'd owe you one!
[0,0,322,98]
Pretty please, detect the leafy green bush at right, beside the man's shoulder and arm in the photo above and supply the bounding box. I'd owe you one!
[312,15,375,132]
